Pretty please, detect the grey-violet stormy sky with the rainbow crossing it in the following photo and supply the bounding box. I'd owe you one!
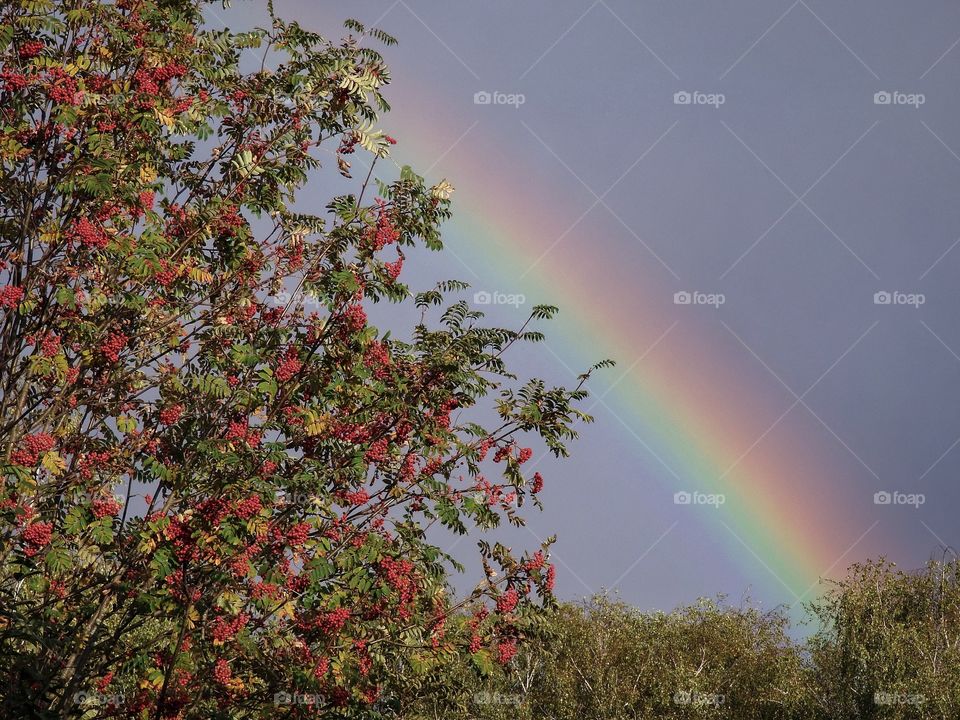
[225,0,960,616]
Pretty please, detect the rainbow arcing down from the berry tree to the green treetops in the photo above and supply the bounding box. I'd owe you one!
[385,86,869,604]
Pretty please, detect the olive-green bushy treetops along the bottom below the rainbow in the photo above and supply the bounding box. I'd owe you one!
[416,561,960,720]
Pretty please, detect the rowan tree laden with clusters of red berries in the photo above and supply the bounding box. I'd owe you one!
[0,0,589,719]
